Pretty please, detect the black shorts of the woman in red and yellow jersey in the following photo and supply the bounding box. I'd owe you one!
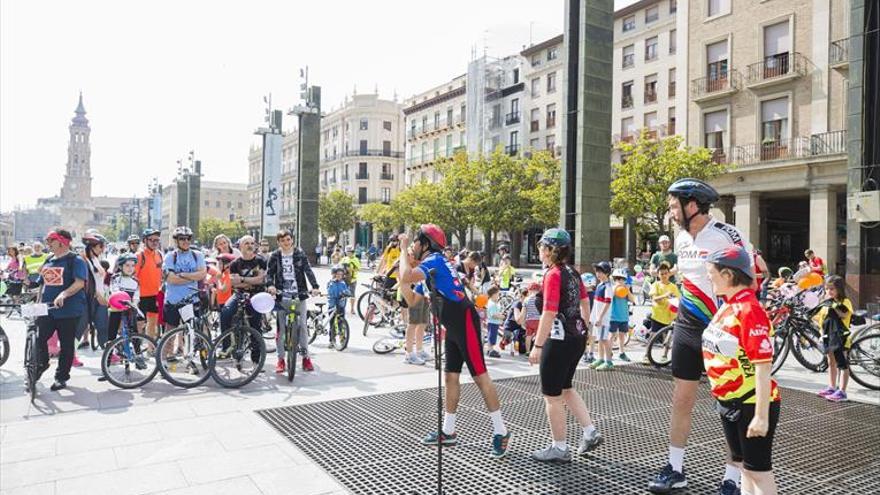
[720,402,779,471]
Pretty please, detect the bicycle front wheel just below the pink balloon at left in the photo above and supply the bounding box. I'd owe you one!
[101,334,159,388]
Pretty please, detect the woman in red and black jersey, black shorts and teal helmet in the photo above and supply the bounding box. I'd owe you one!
[529,228,602,462]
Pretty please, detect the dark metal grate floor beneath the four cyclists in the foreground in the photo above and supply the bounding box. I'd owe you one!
[257,366,880,495]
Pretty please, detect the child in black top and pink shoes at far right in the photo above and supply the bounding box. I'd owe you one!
[816,275,853,402]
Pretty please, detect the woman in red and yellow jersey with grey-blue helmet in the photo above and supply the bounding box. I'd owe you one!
[703,246,780,495]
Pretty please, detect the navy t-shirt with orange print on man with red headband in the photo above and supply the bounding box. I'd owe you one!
[40,251,89,318]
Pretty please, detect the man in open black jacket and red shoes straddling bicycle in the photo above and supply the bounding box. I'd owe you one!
[266,229,321,373]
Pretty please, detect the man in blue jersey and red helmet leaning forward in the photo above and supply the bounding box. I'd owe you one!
[400,224,510,458]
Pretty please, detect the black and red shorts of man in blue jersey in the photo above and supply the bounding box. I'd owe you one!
[440,299,486,376]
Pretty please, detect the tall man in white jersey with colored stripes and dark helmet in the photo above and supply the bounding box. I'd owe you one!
[648,178,745,495]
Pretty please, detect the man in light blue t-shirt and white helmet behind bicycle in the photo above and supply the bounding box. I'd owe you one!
[162,225,207,328]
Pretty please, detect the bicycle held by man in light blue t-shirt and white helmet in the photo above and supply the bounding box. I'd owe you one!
[156,291,211,388]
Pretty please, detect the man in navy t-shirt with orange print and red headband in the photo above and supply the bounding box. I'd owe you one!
[36,229,89,390]
